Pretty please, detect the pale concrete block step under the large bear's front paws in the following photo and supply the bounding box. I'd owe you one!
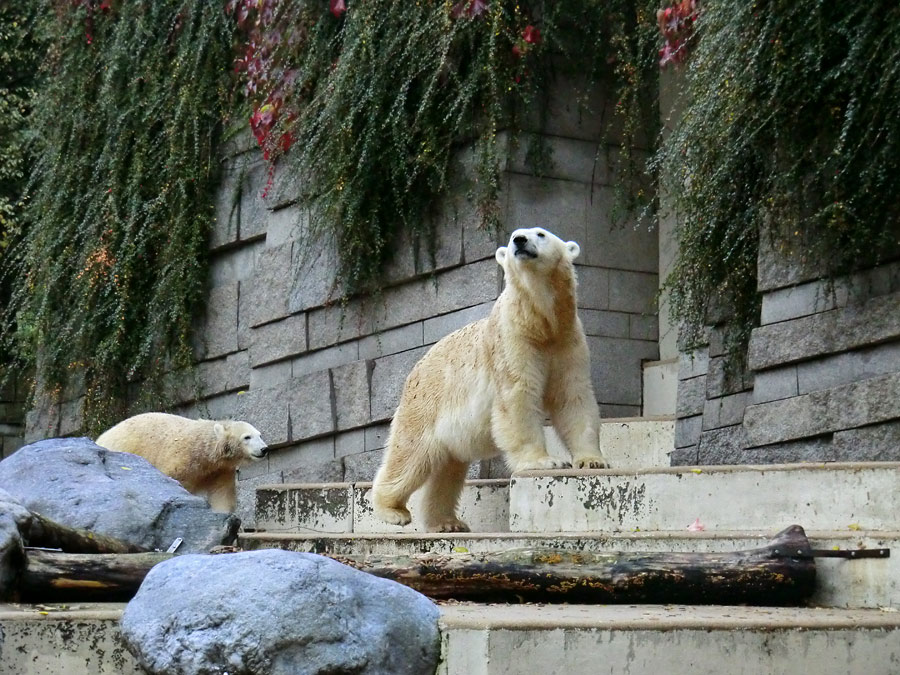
[509,462,900,532]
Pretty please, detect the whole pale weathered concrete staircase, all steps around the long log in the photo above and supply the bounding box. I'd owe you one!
[0,418,900,675]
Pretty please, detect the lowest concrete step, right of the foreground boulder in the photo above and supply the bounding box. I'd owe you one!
[438,604,900,675]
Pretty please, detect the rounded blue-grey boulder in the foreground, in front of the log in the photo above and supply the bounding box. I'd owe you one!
[122,550,440,675]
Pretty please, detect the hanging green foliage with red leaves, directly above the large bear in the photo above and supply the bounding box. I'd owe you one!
[238,0,657,293]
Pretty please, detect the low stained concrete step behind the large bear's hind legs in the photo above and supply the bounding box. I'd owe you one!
[256,479,509,533]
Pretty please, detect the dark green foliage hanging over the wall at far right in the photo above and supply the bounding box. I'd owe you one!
[657,0,900,344]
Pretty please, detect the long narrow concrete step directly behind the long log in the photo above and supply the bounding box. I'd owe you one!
[239,530,900,608]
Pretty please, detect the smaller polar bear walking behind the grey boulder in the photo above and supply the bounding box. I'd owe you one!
[97,413,268,512]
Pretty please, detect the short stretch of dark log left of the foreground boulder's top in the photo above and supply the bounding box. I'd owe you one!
[16,549,174,602]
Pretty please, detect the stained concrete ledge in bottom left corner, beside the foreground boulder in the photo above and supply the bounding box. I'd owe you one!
[0,603,146,675]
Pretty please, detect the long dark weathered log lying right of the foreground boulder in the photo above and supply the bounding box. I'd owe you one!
[334,525,816,606]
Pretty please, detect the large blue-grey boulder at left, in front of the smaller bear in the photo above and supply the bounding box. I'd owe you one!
[0,438,240,553]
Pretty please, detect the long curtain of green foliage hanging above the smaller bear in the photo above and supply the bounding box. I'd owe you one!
[5,0,233,430]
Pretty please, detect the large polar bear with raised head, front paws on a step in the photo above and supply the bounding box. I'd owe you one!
[372,227,606,532]
